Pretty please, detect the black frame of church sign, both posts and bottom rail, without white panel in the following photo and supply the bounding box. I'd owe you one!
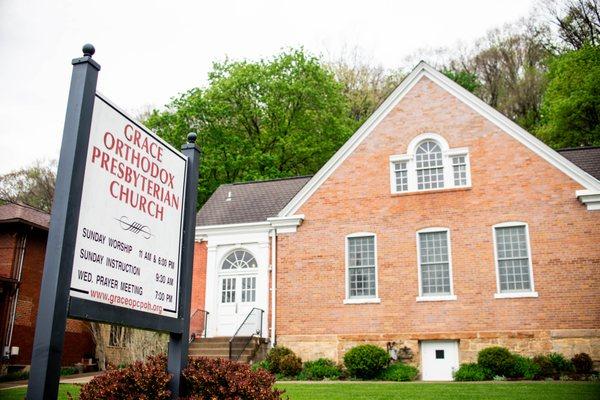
[27,44,200,400]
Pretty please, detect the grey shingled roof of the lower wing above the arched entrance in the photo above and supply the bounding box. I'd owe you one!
[196,176,311,226]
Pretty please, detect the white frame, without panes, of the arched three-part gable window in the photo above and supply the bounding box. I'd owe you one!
[389,133,471,194]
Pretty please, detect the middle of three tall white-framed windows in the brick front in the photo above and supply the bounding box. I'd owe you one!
[417,228,456,301]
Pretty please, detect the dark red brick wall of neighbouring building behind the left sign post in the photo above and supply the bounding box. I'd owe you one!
[0,224,94,365]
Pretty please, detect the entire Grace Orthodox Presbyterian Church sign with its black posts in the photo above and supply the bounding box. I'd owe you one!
[27,45,200,400]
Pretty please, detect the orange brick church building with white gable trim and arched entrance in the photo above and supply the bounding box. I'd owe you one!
[192,63,600,380]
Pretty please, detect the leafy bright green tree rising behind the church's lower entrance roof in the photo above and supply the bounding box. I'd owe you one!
[146,49,357,204]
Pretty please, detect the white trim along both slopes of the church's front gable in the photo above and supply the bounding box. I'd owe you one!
[279,61,600,217]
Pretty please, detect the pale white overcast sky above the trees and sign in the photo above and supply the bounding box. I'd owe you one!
[0,0,536,174]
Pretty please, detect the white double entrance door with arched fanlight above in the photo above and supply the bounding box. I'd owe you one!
[217,249,258,336]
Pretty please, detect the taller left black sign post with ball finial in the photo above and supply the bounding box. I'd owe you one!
[27,44,100,400]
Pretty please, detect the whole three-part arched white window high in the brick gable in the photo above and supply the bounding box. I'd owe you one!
[390,133,471,193]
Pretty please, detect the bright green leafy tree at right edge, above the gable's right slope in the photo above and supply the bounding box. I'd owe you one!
[537,46,600,148]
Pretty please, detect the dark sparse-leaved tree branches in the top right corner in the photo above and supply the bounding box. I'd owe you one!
[545,0,600,50]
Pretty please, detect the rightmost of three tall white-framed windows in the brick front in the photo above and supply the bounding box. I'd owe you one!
[494,222,537,297]
